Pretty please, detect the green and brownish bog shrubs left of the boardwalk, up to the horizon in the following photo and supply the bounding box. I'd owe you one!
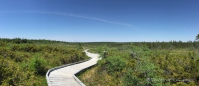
[0,38,88,86]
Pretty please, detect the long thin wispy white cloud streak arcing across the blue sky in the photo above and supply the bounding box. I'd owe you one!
[0,11,133,26]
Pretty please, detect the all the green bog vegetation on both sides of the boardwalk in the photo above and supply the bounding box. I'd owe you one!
[0,36,199,86]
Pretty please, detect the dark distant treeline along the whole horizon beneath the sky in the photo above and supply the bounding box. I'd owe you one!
[0,38,199,49]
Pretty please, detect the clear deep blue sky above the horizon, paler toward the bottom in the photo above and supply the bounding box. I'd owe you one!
[0,0,199,42]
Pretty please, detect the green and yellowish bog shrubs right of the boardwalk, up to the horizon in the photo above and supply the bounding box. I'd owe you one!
[79,41,199,86]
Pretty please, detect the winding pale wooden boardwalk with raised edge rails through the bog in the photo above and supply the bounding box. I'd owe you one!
[48,50,99,86]
